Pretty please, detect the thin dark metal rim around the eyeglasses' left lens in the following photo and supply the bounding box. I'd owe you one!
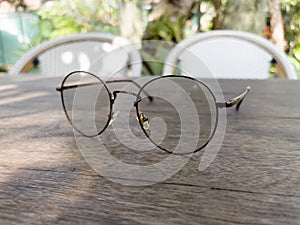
[60,70,113,137]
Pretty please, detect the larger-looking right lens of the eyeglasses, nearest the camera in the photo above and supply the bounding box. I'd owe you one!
[137,76,218,154]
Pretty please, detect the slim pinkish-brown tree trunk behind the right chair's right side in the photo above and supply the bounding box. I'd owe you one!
[269,0,286,51]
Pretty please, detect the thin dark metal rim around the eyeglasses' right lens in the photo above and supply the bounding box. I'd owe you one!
[135,75,219,155]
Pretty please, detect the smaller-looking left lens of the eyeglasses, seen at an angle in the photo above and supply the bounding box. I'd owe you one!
[62,72,111,136]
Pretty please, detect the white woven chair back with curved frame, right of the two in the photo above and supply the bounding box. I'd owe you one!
[163,30,297,79]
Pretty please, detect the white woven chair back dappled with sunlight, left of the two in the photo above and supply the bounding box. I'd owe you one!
[9,33,142,76]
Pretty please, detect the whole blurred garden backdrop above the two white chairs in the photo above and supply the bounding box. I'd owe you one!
[0,0,300,78]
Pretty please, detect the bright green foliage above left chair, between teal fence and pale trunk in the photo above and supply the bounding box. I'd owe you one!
[36,0,119,41]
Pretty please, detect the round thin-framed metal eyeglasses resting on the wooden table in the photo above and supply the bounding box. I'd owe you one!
[56,71,250,154]
